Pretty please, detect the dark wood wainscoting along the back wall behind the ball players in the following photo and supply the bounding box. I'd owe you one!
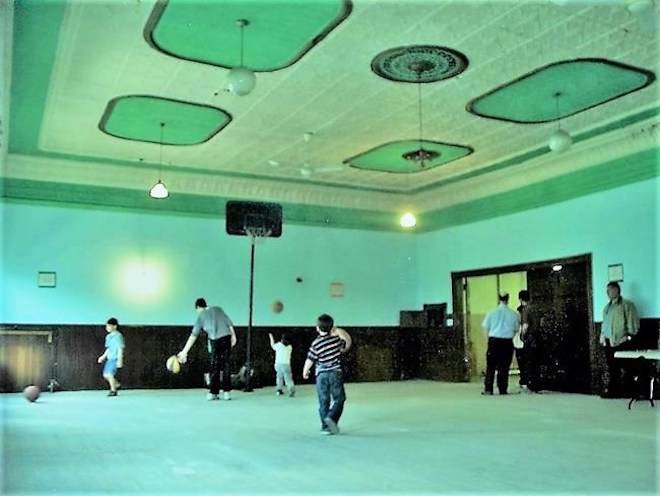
[0,325,463,390]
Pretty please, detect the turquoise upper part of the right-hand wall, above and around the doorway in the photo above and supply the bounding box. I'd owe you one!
[415,177,660,320]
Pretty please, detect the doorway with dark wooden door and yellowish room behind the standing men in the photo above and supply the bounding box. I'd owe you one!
[452,255,594,393]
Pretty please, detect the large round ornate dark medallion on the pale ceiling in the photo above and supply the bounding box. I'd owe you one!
[371,45,468,83]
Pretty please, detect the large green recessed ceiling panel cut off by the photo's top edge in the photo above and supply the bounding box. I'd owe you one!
[144,0,352,71]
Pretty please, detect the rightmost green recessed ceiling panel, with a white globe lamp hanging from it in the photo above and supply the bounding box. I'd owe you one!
[467,59,655,124]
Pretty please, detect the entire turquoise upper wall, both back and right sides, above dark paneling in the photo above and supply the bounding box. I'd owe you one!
[0,177,660,325]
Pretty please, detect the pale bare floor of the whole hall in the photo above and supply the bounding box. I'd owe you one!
[0,381,660,496]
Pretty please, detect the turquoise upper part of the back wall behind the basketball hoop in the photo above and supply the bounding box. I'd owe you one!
[0,202,416,325]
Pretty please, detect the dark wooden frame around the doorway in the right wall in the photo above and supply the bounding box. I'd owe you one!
[451,253,596,383]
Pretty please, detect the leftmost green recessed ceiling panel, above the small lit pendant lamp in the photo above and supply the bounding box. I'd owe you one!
[99,95,231,145]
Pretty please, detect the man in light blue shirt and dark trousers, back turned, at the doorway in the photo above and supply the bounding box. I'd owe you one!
[481,293,520,395]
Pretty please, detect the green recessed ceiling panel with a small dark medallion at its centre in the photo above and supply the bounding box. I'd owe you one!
[344,140,473,174]
